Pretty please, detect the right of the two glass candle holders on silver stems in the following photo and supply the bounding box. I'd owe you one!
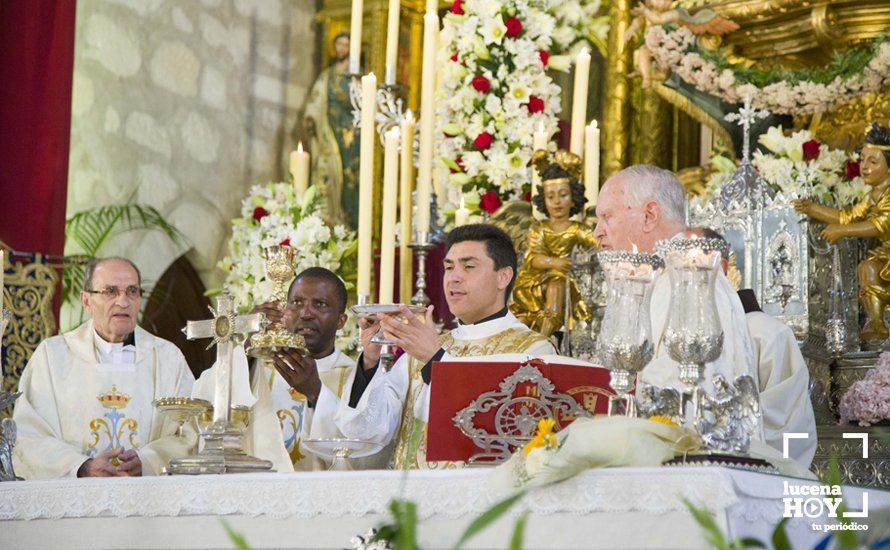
[656,238,729,433]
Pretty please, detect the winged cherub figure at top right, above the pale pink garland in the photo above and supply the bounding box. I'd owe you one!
[624,0,739,88]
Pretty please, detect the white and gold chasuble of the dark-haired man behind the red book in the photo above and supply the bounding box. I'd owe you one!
[335,313,556,469]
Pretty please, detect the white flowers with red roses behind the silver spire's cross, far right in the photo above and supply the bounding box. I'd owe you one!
[703,126,870,208]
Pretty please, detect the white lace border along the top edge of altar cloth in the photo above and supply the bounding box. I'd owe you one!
[0,467,876,521]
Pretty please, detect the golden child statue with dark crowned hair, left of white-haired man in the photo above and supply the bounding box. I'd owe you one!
[510,151,599,336]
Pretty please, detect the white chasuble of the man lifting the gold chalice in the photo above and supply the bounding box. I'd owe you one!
[252,348,356,471]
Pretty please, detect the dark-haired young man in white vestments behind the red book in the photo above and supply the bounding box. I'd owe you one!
[335,224,556,469]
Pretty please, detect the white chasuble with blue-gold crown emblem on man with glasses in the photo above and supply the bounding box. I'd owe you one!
[13,321,195,479]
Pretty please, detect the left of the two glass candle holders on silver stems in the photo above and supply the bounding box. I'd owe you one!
[597,250,663,416]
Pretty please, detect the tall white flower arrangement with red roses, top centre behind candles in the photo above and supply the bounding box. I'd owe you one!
[437,0,608,220]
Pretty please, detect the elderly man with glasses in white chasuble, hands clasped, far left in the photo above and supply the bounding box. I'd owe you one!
[13,258,195,479]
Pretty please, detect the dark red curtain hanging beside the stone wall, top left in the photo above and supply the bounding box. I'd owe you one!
[0,0,76,254]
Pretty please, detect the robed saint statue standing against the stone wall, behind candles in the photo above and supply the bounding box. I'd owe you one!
[303,32,360,229]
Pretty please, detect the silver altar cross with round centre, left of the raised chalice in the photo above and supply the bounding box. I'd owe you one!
[182,294,266,424]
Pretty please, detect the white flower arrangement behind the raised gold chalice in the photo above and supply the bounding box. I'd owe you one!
[219,183,358,353]
